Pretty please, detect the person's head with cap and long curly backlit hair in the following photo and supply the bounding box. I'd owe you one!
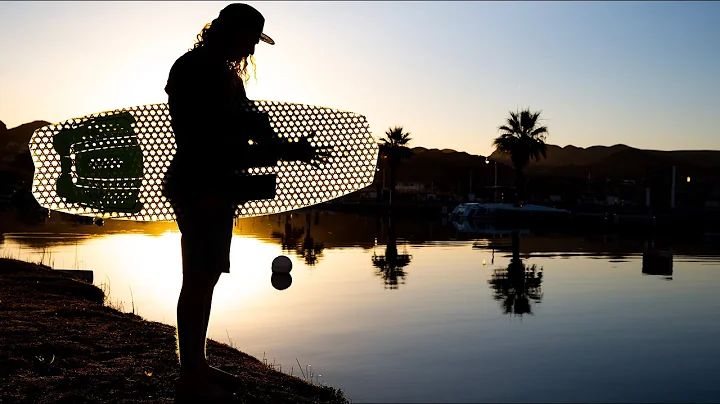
[195,3,275,82]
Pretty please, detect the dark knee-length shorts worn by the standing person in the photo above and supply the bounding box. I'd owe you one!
[172,199,236,275]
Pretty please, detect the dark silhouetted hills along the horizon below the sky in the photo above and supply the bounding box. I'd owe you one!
[0,117,720,187]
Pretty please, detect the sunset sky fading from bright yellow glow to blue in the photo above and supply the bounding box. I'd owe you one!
[0,1,720,155]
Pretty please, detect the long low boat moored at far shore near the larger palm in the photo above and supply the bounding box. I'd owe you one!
[450,202,570,222]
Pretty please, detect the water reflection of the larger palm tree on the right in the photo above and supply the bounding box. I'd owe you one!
[488,232,542,316]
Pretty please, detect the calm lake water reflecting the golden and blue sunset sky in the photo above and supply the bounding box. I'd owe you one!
[0,213,720,402]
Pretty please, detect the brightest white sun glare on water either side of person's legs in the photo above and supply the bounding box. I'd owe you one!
[85,231,280,318]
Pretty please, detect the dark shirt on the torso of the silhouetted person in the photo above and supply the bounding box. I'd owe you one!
[165,47,247,200]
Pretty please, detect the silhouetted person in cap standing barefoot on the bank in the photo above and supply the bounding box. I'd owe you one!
[163,4,318,402]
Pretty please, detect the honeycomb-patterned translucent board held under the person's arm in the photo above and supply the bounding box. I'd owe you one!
[29,101,378,221]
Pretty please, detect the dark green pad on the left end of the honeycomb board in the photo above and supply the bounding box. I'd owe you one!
[53,112,143,213]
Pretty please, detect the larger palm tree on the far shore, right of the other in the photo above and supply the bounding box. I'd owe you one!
[493,109,548,205]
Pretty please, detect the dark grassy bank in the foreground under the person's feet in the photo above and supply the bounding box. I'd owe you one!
[0,259,347,404]
